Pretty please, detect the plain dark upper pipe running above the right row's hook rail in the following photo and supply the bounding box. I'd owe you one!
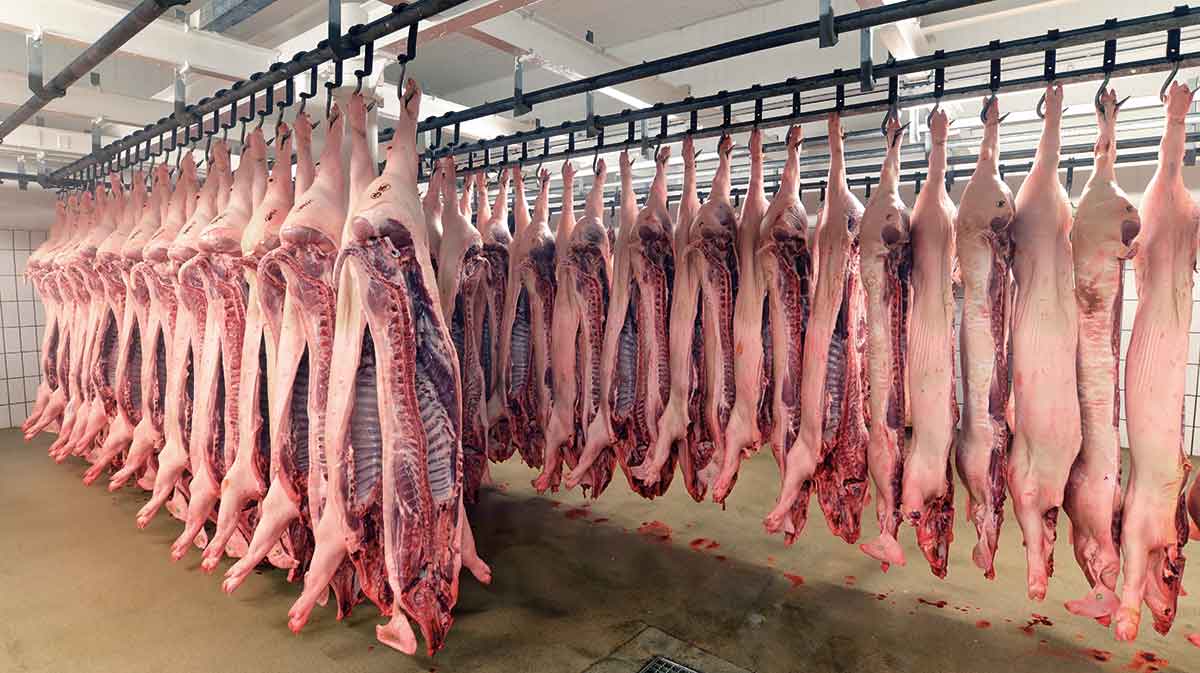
[416,0,991,133]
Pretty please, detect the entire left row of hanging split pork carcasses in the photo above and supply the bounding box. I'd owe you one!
[23,80,491,654]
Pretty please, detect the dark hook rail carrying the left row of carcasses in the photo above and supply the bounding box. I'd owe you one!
[47,0,469,184]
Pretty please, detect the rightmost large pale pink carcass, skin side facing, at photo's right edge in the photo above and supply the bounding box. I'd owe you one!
[1108,83,1200,641]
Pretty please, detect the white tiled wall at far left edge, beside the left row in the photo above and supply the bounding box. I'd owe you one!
[0,229,46,428]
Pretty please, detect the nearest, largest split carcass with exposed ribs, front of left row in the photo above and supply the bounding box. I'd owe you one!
[289,80,491,654]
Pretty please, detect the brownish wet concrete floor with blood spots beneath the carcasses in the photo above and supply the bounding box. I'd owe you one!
[0,431,1200,673]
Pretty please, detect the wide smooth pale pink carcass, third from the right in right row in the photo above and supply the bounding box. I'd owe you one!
[1008,84,1081,600]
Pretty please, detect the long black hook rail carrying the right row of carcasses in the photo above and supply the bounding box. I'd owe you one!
[410,5,1200,181]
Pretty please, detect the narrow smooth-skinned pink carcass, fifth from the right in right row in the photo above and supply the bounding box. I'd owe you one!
[900,110,959,578]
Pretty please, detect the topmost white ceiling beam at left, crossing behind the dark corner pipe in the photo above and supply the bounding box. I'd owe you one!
[0,0,276,80]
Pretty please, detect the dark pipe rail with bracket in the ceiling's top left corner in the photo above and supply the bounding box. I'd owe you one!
[0,0,188,143]
